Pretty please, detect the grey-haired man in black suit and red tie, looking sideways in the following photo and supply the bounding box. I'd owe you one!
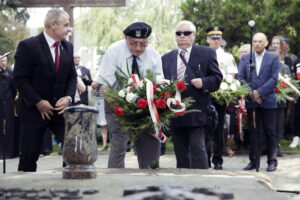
[14,9,77,172]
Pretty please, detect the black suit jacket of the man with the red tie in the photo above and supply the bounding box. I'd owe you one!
[14,33,77,121]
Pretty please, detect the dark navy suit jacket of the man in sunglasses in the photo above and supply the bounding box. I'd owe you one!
[162,45,223,128]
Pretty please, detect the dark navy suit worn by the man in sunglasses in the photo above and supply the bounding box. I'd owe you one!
[162,45,222,169]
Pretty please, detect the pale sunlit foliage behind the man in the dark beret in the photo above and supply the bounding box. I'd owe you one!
[75,0,182,53]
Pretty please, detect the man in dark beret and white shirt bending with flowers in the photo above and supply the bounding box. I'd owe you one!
[92,22,163,168]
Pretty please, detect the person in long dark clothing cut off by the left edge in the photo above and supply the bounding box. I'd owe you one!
[0,54,19,158]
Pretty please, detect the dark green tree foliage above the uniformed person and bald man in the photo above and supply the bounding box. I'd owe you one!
[181,0,300,56]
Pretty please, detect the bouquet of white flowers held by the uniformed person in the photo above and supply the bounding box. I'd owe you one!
[211,74,249,105]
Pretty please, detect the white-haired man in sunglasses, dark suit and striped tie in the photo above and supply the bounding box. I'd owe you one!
[162,21,222,169]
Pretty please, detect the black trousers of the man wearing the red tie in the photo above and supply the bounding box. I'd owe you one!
[18,115,65,172]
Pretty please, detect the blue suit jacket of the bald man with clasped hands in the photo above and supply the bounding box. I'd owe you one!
[238,51,280,109]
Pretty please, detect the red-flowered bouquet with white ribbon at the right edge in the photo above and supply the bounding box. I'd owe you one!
[275,74,300,103]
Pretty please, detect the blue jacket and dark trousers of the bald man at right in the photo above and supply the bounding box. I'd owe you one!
[238,51,280,165]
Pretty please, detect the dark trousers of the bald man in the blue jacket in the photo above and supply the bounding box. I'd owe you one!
[247,108,278,165]
